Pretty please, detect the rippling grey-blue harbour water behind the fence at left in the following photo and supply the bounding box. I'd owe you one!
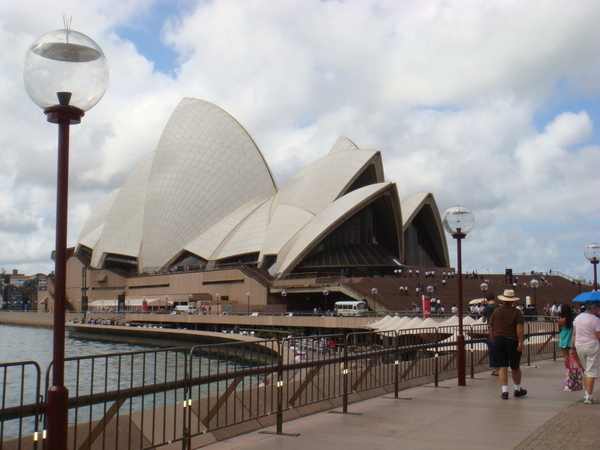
[0,325,264,439]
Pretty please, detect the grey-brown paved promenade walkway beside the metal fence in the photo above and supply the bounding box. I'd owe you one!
[205,360,600,450]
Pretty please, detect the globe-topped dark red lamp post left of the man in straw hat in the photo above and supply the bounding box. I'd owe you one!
[443,205,475,386]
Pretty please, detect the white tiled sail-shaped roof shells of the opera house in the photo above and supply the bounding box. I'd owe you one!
[79,98,445,273]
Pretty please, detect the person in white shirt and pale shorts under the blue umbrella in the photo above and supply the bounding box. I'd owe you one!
[571,300,600,404]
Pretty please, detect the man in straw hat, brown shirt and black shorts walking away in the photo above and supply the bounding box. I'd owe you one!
[489,289,527,400]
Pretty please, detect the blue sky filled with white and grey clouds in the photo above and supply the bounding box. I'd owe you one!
[0,0,600,279]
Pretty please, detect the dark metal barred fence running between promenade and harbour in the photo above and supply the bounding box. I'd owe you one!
[0,321,557,449]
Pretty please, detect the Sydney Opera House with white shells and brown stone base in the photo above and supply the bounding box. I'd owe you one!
[57,98,449,309]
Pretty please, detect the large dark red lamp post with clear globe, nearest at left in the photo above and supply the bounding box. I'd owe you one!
[23,20,108,449]
